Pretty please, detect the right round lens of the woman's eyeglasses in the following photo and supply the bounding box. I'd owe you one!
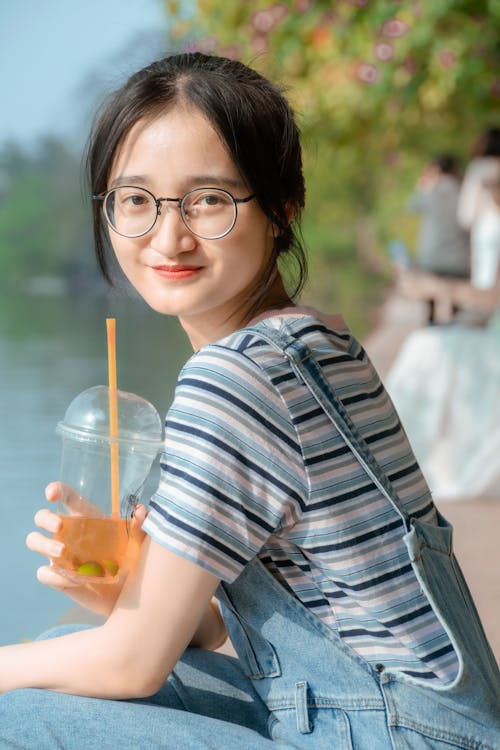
[181,188,236,240]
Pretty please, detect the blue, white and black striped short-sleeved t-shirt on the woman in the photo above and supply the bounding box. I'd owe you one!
[144,308,457,683]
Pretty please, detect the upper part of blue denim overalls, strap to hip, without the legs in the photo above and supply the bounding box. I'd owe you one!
[221,324,500,750]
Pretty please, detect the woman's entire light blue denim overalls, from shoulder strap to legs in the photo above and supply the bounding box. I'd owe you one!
[0,324,500,750]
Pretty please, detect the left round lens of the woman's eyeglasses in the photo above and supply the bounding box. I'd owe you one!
[104,186,157,237]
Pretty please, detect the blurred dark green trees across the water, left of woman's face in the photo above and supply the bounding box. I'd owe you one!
[0,138,92,286]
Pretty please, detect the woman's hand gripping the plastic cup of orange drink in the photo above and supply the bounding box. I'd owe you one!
[26,482,147,616]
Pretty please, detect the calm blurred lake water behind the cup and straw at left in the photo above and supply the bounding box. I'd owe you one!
[0,293,191,645]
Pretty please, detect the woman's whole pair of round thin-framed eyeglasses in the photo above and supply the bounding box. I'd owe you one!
[92,185,255,240]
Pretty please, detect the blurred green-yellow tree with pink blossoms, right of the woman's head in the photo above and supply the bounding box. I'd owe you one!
[165,0,500,328]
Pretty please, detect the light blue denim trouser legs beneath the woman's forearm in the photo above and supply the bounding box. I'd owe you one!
[0,626,272,750]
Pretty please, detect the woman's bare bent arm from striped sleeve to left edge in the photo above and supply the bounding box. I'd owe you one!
[0,537,223,699]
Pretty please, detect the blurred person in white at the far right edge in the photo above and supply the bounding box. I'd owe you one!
[457,127,500,289]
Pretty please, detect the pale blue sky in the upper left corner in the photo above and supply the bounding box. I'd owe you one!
[0,0,167,148]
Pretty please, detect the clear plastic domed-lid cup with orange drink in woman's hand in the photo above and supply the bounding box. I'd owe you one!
[52,385,163,583]
